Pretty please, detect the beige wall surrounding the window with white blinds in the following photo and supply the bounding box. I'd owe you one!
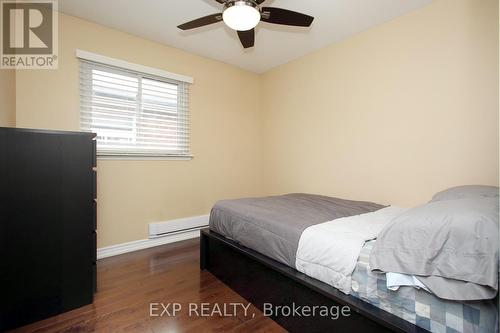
[17,15,262,247]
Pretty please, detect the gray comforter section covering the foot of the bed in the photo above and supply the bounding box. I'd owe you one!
[210,193,384,268]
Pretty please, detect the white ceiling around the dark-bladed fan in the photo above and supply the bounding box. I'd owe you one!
[59,0,432,73]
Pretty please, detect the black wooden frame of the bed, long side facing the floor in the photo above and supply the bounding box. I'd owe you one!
[200,229,428,333]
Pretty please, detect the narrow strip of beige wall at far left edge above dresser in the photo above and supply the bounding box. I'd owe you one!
[0,69,16,127]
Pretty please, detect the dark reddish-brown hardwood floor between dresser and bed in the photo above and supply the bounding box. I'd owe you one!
[8,239,286,333]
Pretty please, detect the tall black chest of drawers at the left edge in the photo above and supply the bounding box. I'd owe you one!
[0,128,96,332]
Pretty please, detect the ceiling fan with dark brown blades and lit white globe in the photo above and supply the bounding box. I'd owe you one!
[177,0,314,48]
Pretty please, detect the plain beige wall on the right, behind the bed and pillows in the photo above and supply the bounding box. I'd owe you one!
[262,0,498,205]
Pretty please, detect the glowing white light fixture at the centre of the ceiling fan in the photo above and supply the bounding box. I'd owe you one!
[222,0,260,31]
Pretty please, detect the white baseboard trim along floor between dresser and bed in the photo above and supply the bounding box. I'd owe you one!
[97,229,200,259]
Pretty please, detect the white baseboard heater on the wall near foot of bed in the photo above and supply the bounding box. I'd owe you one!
[149,215,209,238]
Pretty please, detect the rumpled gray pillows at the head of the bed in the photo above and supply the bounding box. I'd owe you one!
[370,197,499,300]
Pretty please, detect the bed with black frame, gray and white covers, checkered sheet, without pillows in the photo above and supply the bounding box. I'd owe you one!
[201,194,498,332]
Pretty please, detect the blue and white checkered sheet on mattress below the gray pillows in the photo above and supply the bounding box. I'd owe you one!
[351,241,498,333]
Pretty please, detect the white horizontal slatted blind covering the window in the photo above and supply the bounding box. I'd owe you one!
[80,59,190,157]
